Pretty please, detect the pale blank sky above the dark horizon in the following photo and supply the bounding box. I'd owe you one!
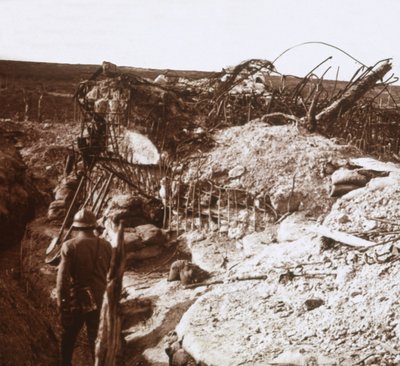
[0,0,400,79]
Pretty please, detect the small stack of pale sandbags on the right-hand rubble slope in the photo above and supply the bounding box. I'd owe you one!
[329,168,370,197]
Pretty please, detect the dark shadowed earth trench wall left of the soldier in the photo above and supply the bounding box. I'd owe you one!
[0,135,58,366]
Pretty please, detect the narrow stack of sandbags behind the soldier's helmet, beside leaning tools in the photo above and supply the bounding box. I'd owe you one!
[47,176,79,221]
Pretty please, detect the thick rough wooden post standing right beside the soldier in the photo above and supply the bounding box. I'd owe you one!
[95,222,125,366]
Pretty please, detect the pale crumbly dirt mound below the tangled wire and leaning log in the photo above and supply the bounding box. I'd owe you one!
[188,120,360,216]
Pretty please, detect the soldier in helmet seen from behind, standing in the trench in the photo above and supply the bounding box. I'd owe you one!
[57,209,112,366]
